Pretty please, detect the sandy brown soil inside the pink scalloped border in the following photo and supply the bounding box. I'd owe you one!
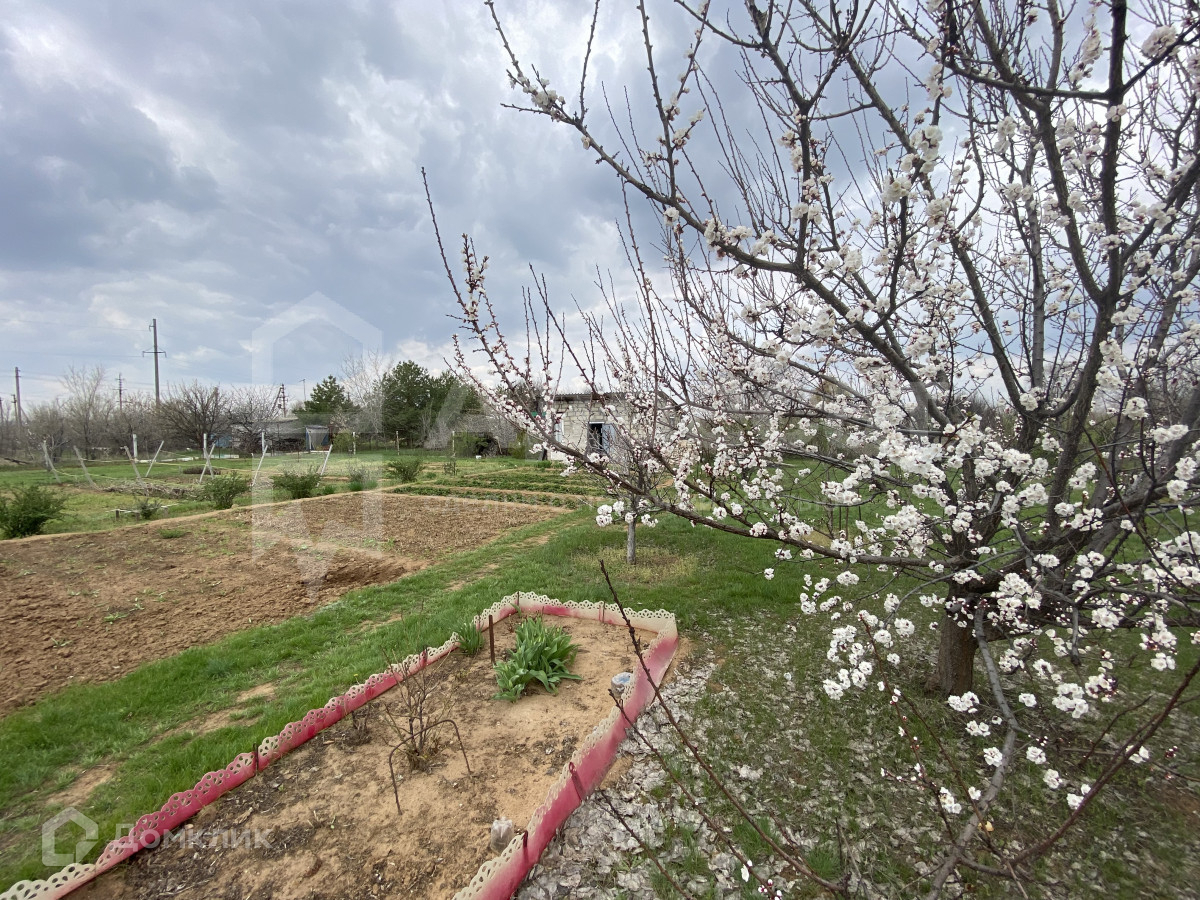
[77,617,636,900]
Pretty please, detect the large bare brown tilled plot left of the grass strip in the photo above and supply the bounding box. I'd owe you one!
[0,491,559,713]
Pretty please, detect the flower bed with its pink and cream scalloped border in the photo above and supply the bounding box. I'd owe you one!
[4,594,677,900]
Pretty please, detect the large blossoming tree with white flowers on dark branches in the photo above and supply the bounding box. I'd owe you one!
[436,0,1200,893]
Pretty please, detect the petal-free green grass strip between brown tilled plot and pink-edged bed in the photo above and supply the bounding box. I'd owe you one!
[0,512,786,883]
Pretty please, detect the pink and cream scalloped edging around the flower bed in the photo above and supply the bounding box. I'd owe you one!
[0,593,678,900]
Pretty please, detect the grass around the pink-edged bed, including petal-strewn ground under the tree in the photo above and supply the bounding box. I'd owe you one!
[0,501,1200,898]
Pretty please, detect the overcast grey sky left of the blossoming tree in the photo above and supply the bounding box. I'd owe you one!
[0,0,686,409]
